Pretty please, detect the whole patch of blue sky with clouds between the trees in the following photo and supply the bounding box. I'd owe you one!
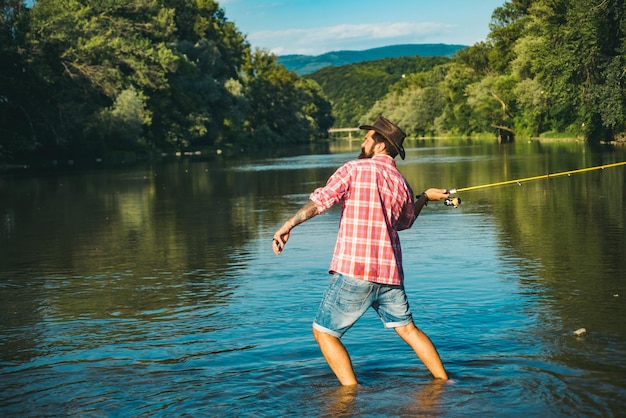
[218,0,505,55]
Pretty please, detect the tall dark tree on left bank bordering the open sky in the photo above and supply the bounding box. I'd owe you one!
[149,0,250,149]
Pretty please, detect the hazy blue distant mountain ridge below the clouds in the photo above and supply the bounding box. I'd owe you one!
[278,44,467,75]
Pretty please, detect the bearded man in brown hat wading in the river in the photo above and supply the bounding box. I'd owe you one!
[272,116,449,385]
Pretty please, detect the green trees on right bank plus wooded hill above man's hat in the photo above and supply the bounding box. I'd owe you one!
[314,0,626,142]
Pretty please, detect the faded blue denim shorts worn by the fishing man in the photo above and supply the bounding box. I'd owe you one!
[313,273,413,338]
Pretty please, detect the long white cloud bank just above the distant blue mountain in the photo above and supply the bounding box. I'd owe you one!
[248,22,455,55]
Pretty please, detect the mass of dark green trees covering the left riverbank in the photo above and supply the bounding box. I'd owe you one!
[0,0,332,163]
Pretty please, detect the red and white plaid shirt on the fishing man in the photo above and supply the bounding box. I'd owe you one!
[310,155,415,285]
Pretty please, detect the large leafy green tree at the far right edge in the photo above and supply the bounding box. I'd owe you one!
[519,0,625,141]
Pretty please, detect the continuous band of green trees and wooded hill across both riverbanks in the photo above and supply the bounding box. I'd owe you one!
[0,0,626,167]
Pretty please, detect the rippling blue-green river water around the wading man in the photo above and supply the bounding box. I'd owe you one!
[0,139,626,417]
